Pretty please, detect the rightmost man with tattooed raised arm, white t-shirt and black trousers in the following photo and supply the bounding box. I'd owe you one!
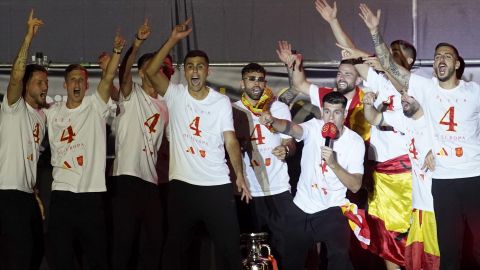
[360,4,480,269]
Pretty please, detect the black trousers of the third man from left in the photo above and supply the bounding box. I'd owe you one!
[110,175,165,270]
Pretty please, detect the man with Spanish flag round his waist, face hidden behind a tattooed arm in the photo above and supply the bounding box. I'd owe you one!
[315,0,416,270]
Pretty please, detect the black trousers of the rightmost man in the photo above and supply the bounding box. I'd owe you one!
[432,176,480,270]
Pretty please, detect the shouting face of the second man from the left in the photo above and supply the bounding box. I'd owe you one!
[63,69,88,107]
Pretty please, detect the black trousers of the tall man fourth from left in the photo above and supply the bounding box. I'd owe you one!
[162,180,241,270]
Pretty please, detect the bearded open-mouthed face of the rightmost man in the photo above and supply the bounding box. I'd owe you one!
[433,46,460,82]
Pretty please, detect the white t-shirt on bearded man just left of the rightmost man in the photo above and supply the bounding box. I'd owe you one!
[384,112,433,212]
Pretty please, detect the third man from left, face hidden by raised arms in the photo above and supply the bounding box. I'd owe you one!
[111,20,173,270]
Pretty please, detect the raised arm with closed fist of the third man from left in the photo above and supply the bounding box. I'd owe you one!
[119,19,150,97]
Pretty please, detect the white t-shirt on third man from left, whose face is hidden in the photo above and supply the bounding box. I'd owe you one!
[113,83,168,184]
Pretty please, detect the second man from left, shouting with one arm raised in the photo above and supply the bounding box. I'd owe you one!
[45,31,125,270]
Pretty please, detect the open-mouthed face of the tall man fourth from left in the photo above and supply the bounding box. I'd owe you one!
[185,56,209,92]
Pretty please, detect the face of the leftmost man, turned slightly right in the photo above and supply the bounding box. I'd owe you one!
[25,71,48,108]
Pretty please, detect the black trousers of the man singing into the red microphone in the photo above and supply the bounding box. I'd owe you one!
[282,204,353,270]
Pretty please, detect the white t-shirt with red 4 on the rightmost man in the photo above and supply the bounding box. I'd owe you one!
[408,74,480,179]
